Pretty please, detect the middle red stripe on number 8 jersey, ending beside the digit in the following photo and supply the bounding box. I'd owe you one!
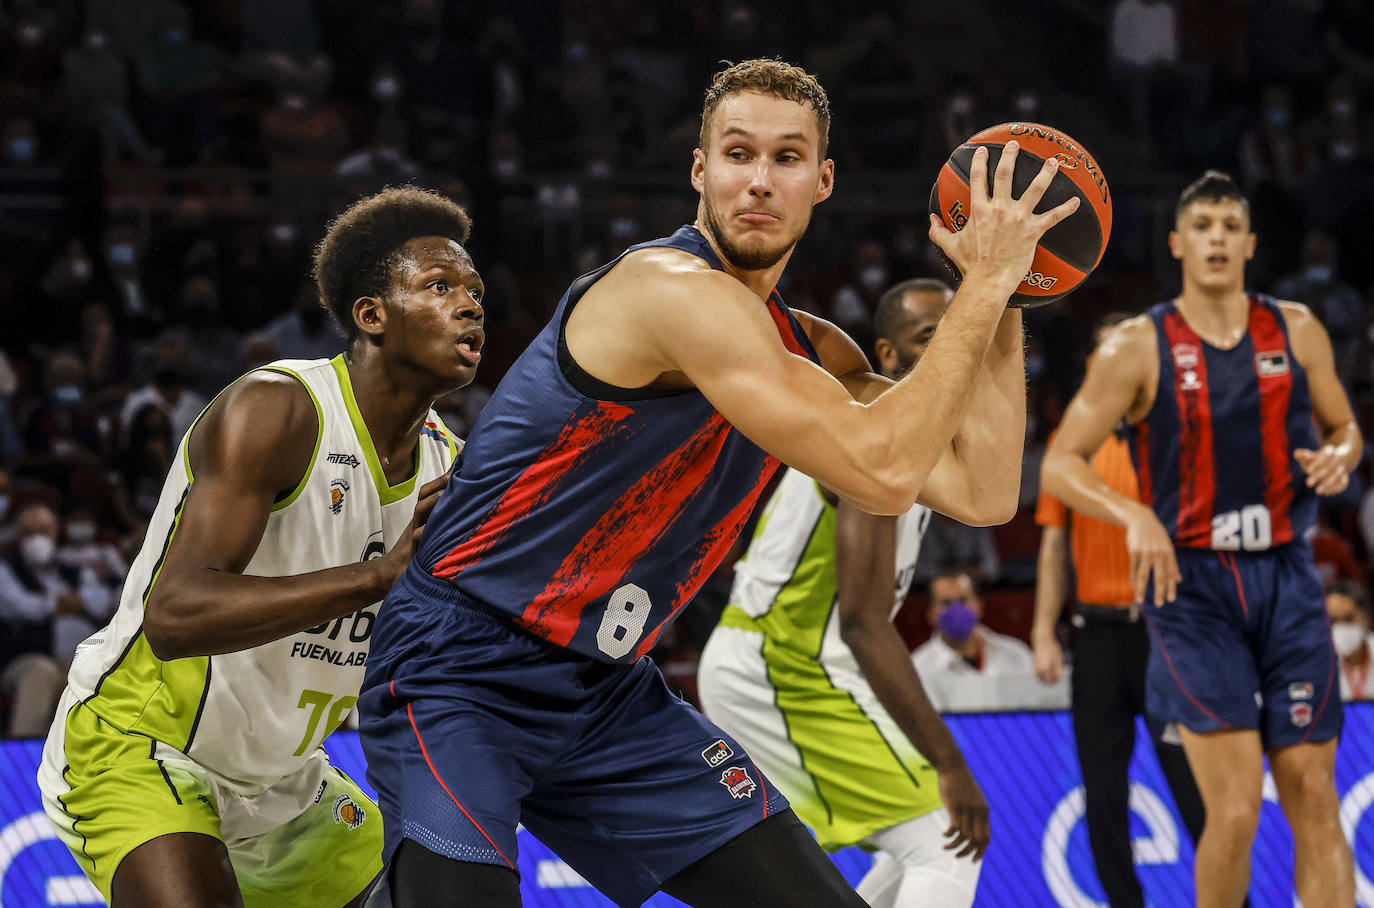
[517,413,732,646]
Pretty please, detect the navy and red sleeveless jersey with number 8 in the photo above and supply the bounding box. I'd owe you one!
[403,227,819,662]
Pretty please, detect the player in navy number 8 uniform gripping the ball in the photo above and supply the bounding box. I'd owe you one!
[359,60,1079,908]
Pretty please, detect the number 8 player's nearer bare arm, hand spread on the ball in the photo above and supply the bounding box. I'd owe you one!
[629,143,1076,514]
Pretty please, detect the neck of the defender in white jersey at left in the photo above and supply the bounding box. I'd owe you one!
[344,343,434,469]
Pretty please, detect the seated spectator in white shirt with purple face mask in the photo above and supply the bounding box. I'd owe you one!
[911,570,1037,712]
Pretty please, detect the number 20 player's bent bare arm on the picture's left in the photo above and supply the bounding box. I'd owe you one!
[1040,316,1179,606]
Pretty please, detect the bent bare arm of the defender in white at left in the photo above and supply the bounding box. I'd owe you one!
[143,372,441,659]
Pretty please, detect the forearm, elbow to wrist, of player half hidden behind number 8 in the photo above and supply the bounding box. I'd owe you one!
[845,621,963,772]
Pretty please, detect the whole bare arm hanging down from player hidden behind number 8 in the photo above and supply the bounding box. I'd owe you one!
[835,501,991,860]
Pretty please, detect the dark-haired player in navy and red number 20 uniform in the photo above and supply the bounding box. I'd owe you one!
[1043,172,1363,908]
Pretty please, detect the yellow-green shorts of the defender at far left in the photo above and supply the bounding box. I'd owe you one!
[38,694,382,908]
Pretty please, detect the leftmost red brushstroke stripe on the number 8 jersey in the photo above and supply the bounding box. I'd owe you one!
[431,401,633,580]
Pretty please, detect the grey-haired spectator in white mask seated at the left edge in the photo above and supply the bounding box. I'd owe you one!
[0,503,115,738]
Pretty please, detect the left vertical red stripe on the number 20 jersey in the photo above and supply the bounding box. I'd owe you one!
[1164,310,1216,548]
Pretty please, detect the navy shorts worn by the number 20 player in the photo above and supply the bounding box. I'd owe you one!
[1145,543,1341,750]
